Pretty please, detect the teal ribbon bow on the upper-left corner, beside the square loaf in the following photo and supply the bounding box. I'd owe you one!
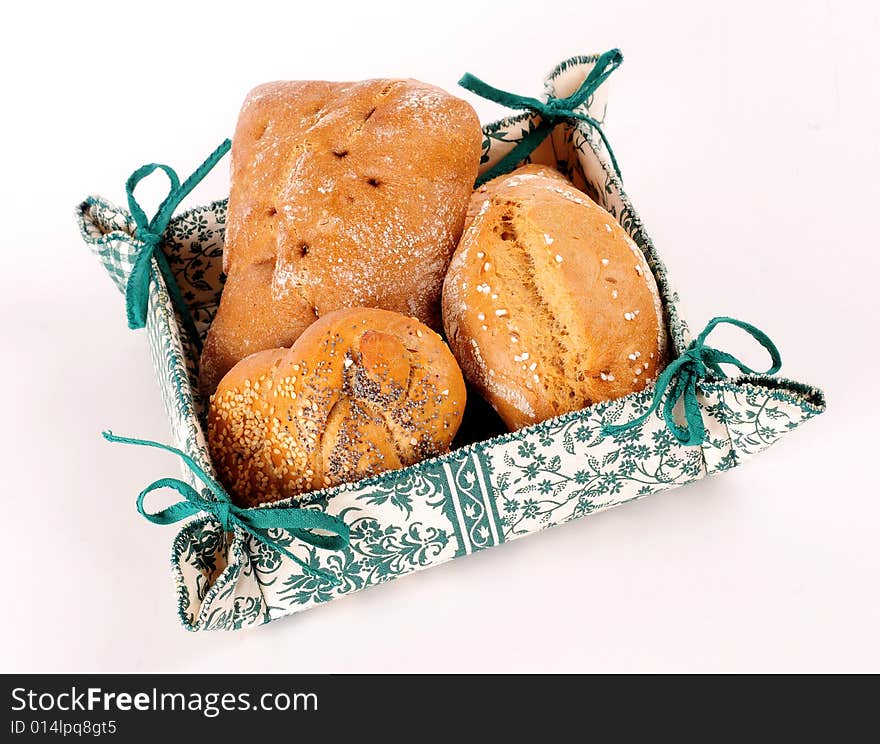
[125,139,232,350]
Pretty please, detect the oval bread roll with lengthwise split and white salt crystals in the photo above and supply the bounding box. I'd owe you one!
[443,166,667,430]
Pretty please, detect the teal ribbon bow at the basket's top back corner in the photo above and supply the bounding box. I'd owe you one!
[458,49,623,186]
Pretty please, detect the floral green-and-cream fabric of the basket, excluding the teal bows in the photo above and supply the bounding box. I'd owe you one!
[78,56,825,630]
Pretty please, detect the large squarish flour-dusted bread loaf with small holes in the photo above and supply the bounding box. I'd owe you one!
[201,80,482,392]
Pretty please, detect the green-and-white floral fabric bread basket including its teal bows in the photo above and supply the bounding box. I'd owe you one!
[77,50,825,631]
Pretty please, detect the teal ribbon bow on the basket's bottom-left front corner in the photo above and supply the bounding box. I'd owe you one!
[103,431,350,584]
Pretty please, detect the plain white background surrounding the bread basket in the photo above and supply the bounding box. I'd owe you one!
[0,0,880,673]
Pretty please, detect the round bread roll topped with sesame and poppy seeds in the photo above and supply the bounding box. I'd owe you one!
[208,308,466,506]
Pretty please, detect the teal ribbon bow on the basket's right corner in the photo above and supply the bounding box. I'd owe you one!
[603,317,782,446]
